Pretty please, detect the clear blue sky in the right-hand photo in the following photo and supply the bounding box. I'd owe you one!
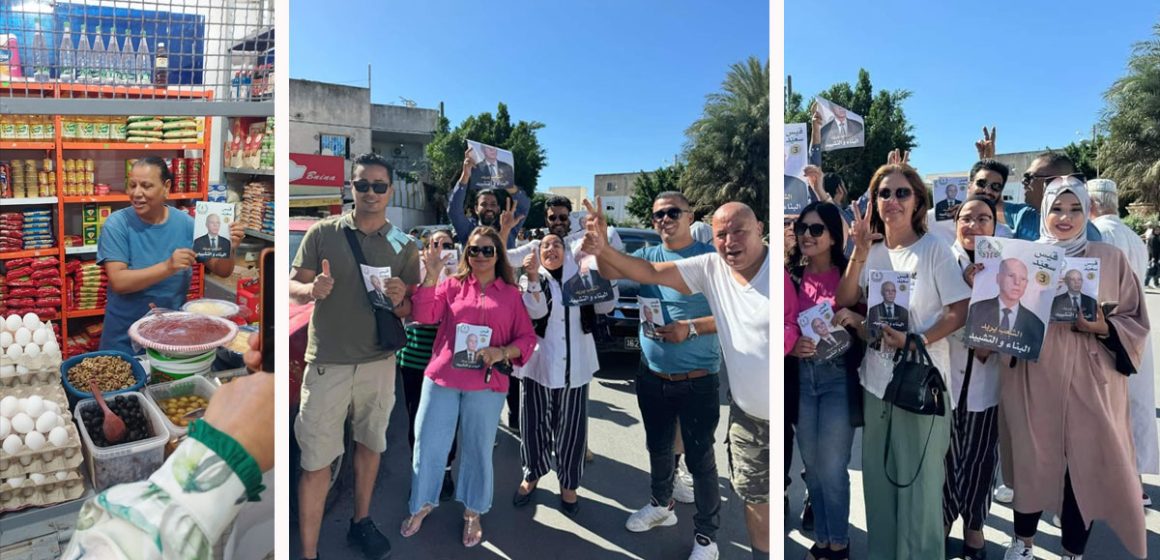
[785,0,1160,174]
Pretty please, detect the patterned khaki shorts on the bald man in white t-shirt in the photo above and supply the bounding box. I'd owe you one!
[726,402,769,503]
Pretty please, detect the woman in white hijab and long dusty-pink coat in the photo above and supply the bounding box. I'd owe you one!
[999,176,1151,560]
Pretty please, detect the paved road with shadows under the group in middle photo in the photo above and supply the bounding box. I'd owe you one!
[291,356,752,560]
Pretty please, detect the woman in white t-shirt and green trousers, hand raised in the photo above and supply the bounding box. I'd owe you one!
[838,165,971,560]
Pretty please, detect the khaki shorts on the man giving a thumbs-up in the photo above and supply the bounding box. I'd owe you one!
[293,356,394,471]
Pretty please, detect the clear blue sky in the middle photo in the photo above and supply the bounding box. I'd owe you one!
[290,0,769,195]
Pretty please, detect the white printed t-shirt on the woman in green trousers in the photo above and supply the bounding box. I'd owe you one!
[858,234,971,399]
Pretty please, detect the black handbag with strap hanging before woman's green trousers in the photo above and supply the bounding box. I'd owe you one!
[882,334,947,488]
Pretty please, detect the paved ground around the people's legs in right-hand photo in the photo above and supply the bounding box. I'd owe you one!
[784,290,1160,560]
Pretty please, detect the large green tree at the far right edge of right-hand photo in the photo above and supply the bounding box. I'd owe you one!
[1099,23,1160,204]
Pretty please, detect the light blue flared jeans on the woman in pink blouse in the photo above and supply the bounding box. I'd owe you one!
[409,378,507,515]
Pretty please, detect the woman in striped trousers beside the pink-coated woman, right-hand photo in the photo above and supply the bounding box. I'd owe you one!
[943,196,1009,560]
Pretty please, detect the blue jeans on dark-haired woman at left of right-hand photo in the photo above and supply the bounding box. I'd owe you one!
[797,358,854,546]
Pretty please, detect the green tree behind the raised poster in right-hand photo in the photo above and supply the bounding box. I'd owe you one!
[784,68,918,199]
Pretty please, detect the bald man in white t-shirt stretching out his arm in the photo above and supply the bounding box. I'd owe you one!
[583,197,769,559]
